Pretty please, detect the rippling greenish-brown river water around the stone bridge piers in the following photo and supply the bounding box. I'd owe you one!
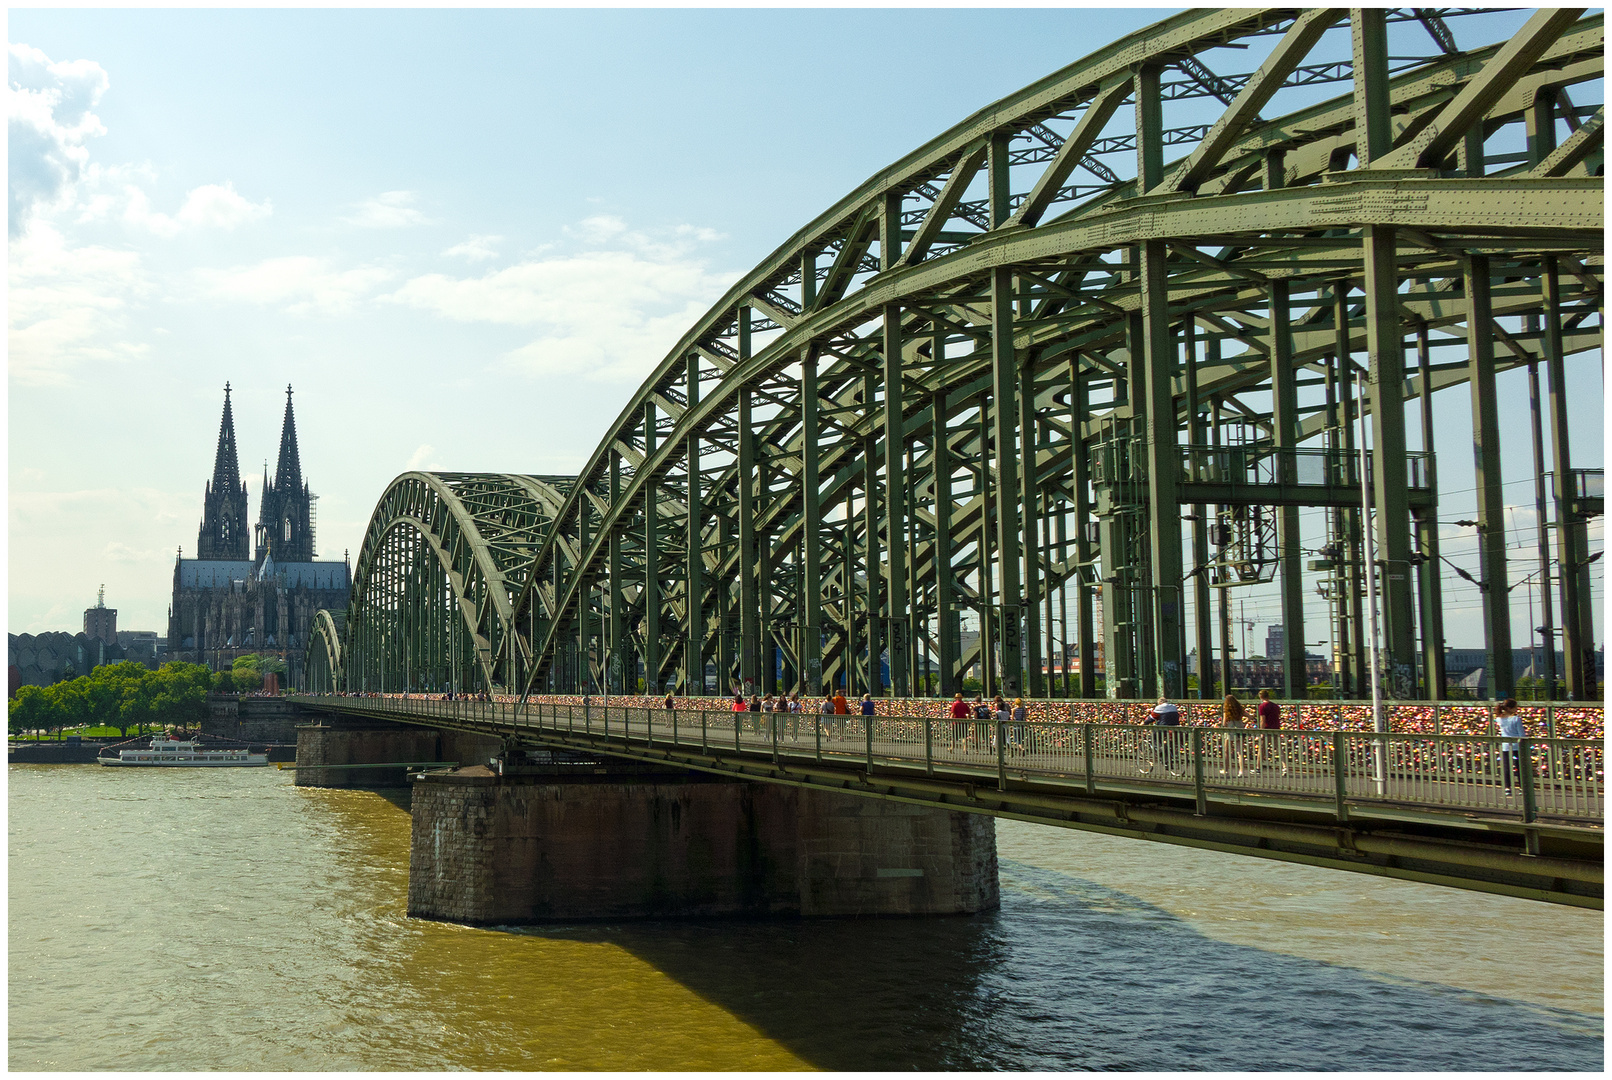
[8,766,1604,1070]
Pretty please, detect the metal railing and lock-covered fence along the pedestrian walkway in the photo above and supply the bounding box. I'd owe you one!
[290,696,1606,825]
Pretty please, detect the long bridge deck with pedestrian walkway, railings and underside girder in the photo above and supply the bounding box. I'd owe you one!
[290,696,1604,906]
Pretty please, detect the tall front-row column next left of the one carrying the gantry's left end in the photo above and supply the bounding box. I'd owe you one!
[991,268,1024,696]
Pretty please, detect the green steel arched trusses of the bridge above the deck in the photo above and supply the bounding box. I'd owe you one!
[311,8,1604,709]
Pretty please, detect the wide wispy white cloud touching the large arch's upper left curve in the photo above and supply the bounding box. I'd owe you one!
[382,216,732,382]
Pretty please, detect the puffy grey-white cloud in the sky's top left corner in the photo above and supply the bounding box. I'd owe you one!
[6,45,111,237]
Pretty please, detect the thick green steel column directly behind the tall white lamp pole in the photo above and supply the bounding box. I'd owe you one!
[1364,226,1415,698]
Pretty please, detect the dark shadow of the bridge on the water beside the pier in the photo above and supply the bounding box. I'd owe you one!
[513,861,1604,1072]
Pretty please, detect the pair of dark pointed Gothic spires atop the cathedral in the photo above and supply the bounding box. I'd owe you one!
[197,382,313,564]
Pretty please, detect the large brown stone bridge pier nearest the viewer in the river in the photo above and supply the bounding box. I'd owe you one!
[408,767,999,925]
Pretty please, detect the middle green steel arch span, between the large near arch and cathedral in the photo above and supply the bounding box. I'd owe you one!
[339,472,571,692]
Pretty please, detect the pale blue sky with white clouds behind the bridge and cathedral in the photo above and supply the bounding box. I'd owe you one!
[6,8,1604,660]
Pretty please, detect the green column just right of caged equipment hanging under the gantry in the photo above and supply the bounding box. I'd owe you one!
[1270,280,1309,698]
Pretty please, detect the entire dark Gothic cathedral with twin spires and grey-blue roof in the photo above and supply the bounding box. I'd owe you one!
[168,384,351,687]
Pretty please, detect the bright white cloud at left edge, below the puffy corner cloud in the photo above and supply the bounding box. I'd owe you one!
[8,221,152,385]
